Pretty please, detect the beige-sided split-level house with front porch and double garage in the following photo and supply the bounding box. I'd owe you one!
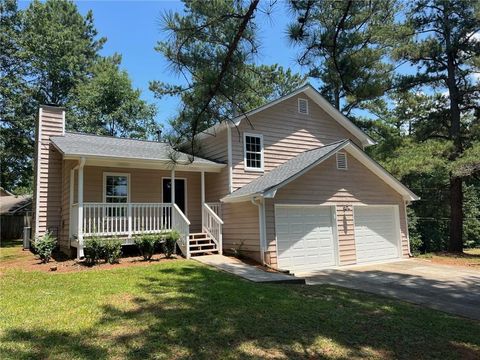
[34,84,418,272]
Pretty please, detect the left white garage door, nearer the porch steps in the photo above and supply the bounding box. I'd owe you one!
[275,205,336,272]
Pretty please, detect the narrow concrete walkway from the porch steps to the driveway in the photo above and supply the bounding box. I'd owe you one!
[192,255,305,284]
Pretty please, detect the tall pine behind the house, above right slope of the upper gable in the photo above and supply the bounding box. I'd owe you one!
[288,0,400,114]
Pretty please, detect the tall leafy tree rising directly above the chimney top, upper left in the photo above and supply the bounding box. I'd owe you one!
[21,0,106,106]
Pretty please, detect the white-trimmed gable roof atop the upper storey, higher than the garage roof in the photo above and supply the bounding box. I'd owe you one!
[200,83,376,146]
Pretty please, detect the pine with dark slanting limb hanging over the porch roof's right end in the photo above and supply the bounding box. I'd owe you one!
[150,0,304,152]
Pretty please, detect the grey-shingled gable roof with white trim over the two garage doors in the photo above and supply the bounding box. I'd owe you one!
[221,139,419,202]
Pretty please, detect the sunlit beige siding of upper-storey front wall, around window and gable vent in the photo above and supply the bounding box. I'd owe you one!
[231,94,361,190]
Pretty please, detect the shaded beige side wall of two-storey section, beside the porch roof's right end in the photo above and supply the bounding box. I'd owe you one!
[199,126,228,202]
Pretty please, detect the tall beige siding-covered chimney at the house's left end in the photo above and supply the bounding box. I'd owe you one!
[33,105,65,242]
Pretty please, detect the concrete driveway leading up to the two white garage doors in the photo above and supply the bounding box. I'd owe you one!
[296,259,480,320]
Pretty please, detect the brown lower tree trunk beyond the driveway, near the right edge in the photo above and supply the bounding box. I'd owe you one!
[448,177,463,252]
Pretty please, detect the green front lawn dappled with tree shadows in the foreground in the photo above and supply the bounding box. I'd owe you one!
[0,249,480,359]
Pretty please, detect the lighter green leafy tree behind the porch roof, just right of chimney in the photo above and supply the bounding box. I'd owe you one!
[67,55,158,138]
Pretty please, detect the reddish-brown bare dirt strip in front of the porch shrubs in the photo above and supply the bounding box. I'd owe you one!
[0,246,182,273]
